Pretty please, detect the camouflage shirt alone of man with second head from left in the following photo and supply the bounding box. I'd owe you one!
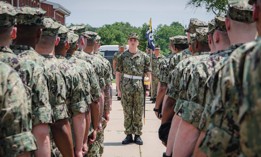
[13,45,68,122]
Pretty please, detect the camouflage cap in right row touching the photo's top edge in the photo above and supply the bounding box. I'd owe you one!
[227,0,254,23]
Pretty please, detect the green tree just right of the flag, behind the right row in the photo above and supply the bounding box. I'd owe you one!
[154,22,185,55]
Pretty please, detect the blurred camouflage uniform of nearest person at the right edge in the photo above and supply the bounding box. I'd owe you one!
[238,38,261,156]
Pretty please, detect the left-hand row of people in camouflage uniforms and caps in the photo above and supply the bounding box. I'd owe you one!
[0,1,112,157]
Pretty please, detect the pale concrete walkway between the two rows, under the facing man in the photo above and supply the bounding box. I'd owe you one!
[103,86,165,157]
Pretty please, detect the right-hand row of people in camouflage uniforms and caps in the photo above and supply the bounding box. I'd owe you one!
[154,0,261,157]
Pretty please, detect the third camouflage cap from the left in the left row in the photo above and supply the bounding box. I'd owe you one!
[42,17,61,36]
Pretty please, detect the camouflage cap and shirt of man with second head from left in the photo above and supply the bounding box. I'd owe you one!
[12,7,68,122]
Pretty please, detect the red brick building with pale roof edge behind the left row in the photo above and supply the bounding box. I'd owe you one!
[3,0,71,24]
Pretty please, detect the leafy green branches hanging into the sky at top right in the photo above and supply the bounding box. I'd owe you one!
[188,0,228,15]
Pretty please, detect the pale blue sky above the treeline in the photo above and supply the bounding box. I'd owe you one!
[49,0,214,28]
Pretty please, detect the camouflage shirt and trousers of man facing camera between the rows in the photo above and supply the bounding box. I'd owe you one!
[117,50,151,135]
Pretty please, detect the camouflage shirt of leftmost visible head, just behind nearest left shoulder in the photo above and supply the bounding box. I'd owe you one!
[0,47,52,125]
